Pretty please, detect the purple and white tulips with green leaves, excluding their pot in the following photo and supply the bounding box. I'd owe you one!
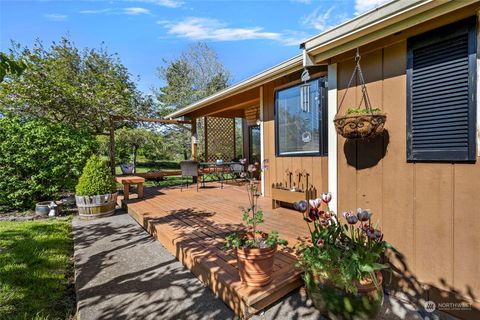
[294,193,394,293]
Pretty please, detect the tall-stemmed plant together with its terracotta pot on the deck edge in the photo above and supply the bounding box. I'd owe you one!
[225,159,287,287]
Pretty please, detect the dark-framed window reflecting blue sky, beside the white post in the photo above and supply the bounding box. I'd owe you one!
[275,78,327,156]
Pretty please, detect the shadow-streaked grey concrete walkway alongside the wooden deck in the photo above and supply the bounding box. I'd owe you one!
[73,212,421,320]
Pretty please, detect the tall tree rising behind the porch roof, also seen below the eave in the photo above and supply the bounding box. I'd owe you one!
[156,43,231,159]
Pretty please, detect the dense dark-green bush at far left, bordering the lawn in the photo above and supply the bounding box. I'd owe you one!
[0,117,96,210]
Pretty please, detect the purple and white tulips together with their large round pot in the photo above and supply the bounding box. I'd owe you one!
[294,193,394,319]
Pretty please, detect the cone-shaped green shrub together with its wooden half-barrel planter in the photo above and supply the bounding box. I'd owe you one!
[75,155,117,219]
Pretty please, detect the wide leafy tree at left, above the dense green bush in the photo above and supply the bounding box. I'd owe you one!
[0,37,152,134]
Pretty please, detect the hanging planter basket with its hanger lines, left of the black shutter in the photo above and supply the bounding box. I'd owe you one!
[333,49,387,140]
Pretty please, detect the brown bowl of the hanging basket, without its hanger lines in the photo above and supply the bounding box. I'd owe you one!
[333,113,387,140]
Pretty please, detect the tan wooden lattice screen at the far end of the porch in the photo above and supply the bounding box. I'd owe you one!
[204,117,235,161]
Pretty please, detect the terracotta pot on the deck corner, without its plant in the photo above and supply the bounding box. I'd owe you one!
[236,246,277,287]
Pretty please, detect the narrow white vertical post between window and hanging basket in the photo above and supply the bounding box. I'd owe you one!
[327,63,340,212]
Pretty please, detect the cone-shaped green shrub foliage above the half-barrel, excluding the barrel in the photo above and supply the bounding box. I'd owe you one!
[76,155,117,196]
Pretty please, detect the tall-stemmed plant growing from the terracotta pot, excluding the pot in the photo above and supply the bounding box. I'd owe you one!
[225,159,287,249]
